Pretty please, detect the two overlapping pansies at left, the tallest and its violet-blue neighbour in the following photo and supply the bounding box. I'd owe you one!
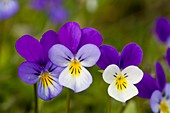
[16,22,103,100]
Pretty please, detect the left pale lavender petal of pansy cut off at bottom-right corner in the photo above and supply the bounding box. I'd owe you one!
[150,90,162,113]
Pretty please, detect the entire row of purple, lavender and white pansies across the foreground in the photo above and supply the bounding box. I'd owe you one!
[16,19,170,113]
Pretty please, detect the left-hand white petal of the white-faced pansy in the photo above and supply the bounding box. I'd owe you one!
[103,64,120,84]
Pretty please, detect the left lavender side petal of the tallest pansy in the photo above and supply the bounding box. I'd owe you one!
[48,44,74,67]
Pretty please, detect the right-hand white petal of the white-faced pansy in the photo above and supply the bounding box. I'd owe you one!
[122,66,143,84]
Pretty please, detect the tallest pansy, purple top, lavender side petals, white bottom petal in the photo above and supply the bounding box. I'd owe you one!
[49,22,102,93]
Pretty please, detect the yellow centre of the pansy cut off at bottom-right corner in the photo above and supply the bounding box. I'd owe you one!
[159,99,170,113]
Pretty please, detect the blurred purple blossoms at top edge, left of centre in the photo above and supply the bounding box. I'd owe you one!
[31,0,68,24]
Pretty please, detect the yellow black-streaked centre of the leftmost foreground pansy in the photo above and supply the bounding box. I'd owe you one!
[40,72,53,88]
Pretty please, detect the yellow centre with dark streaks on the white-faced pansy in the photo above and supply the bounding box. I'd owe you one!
[115,74,127,91]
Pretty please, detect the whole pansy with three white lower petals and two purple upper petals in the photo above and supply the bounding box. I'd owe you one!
[97,43,143,102]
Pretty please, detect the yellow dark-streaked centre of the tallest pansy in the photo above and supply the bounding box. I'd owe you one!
[69,60,82,76]
